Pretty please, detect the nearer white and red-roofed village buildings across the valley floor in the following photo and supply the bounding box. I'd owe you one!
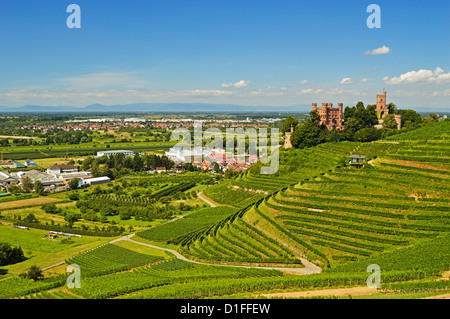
[0,147,258,193]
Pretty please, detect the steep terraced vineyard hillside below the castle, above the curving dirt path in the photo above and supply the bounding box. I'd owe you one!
[180,121,450,269]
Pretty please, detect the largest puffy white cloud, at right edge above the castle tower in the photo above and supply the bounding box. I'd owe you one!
[383,67,450,84]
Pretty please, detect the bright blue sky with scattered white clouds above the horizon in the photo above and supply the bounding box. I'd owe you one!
[0,0,450,110]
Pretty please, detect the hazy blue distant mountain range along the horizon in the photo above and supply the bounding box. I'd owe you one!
[0,103,444,114]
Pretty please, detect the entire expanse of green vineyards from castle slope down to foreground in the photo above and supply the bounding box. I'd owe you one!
[0,121,450,299]
